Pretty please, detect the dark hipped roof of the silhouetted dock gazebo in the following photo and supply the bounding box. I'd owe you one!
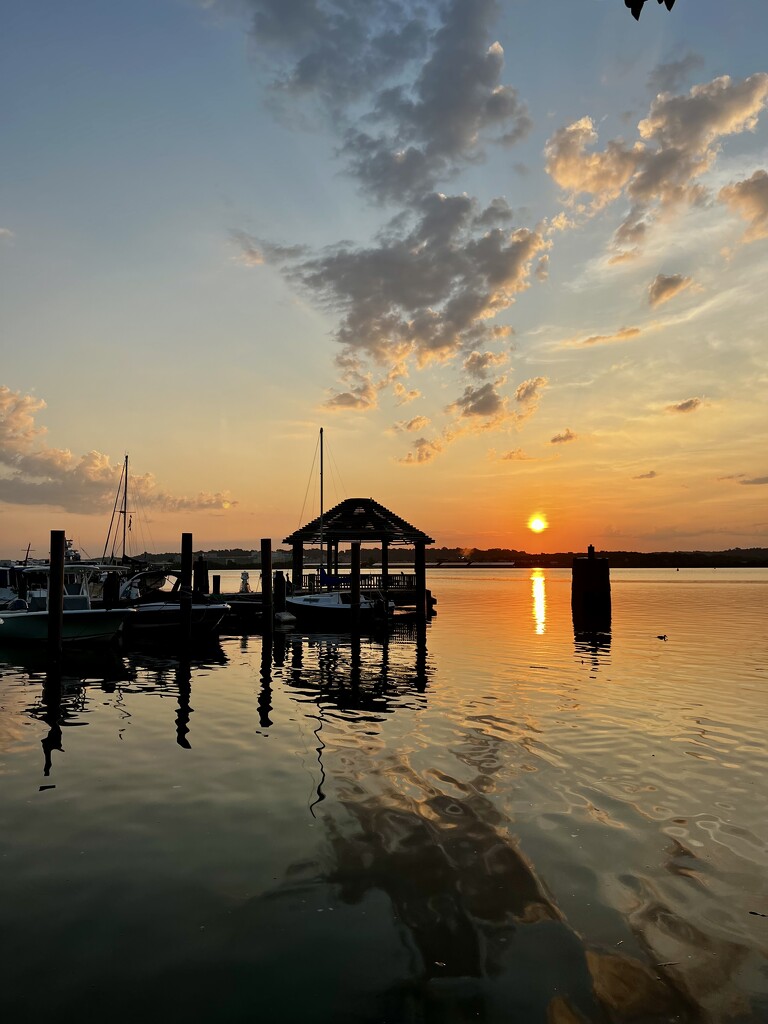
[283,498,434,544]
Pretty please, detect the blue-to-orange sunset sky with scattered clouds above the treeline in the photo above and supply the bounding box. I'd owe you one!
[0,0,768,558]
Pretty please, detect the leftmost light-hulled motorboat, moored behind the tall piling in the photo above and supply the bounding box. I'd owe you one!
[0,565,133,643]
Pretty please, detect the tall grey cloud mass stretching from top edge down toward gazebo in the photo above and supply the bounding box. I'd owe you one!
[225,0,551,450]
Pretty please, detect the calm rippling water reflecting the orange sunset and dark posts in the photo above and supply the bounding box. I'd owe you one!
[0,569,768,1024]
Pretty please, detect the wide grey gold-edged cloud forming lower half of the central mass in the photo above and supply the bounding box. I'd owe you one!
[241,194,549,374]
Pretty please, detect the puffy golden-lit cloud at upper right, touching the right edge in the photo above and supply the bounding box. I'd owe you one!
[545,72,768,253]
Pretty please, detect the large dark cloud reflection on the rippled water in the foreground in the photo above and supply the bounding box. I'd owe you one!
[272,712,695,1024]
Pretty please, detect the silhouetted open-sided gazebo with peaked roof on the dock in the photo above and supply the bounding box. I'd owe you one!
[283,498,434,610]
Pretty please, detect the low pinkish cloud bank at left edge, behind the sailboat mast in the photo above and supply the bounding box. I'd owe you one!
[0,385,237,514]
